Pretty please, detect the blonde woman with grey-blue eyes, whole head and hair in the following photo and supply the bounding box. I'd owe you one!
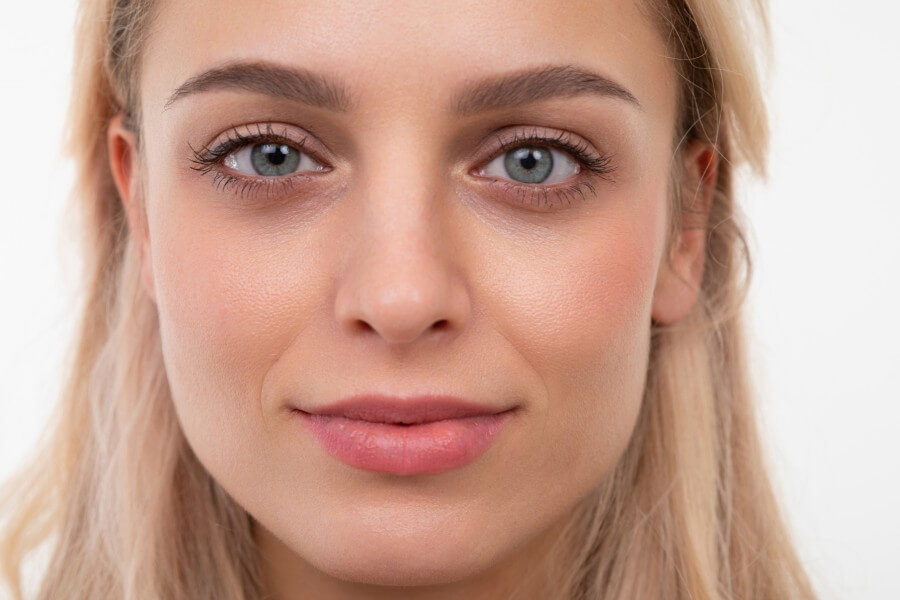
[0,0,813,599]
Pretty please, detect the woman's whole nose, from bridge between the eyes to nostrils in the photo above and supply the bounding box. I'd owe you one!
[335,128,468,343]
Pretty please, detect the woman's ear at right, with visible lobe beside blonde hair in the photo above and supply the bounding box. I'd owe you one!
[651,140,718,324]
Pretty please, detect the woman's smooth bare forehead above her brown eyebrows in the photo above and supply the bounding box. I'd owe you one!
[142,0,675,124]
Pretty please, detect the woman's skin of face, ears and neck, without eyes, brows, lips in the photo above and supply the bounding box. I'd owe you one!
[108,0,715,599]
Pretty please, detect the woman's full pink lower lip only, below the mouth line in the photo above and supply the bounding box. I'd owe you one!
[294,410,513,475]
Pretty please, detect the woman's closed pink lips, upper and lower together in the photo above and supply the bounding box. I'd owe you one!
[293,395,514,475]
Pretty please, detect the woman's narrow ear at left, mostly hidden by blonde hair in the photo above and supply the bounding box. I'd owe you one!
[106,113,156,302]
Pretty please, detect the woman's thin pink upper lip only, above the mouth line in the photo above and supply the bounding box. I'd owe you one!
[302,394,511,424]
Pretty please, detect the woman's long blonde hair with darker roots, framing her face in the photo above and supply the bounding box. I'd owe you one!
[0,0,814,600]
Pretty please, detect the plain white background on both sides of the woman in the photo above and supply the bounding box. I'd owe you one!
[0,0,900,600]
